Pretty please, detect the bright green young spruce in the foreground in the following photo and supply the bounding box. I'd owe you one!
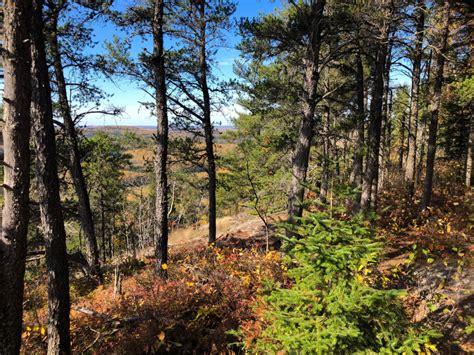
[242,213,435,354]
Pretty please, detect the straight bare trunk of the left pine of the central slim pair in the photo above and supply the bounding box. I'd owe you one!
[153,0,168,277]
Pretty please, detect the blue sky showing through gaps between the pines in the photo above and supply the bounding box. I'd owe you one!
[82,0,282,126]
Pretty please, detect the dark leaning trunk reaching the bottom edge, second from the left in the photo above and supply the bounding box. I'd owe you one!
[31,0,71,354]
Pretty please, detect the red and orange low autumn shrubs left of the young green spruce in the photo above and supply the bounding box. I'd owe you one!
[25,247,284,353]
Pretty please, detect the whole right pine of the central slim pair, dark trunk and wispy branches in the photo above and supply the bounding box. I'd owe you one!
[168,0,236,244]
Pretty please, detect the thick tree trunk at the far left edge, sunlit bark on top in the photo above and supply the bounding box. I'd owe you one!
[0,0,31,354]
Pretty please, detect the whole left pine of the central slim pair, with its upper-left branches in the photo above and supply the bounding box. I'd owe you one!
[104,0,172,268]
